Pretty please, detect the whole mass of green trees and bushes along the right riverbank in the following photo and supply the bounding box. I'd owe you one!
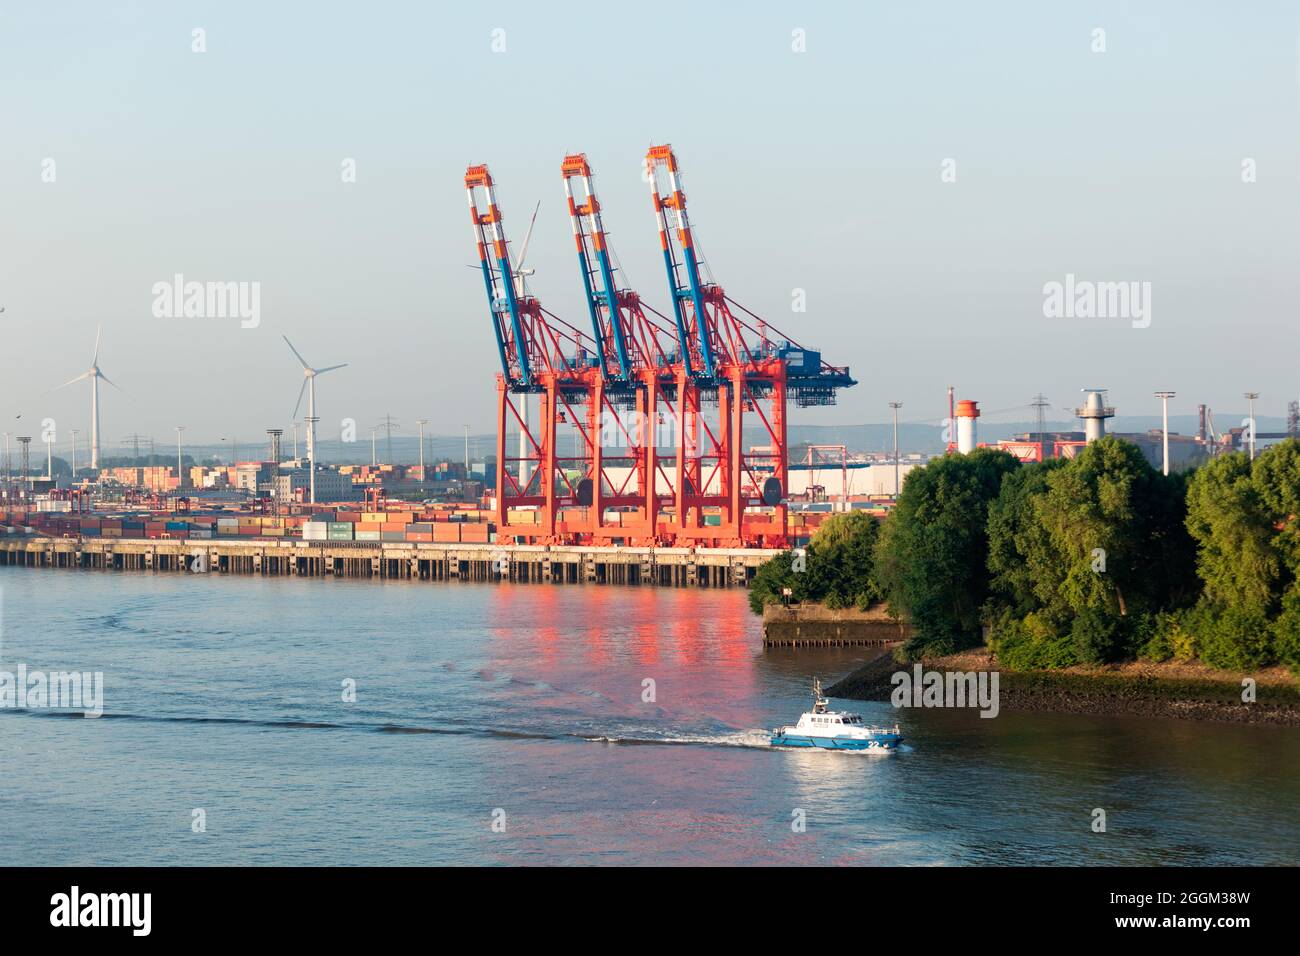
[750,437,1300,670]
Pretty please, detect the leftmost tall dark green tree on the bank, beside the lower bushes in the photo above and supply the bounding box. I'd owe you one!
[876,449,1019,653]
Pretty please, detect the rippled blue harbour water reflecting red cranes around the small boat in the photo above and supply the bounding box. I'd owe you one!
[0,568,1300,865]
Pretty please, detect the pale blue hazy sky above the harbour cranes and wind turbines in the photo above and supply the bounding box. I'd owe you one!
[0,0,1300,449]
